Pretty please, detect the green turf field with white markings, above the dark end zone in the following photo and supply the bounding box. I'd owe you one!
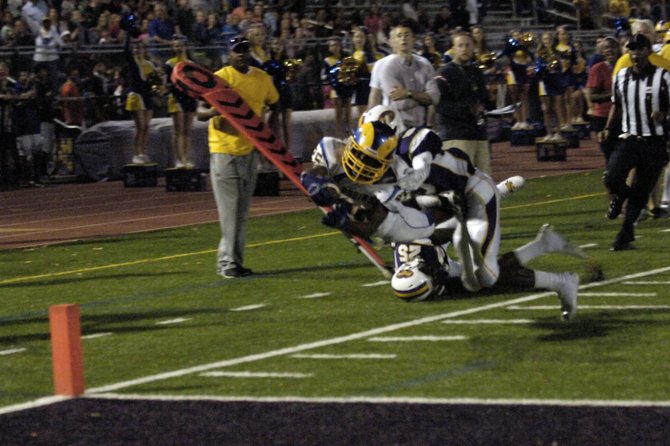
[0,172,670,408]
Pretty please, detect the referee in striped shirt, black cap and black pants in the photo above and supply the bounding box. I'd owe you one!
[599,33,670,251]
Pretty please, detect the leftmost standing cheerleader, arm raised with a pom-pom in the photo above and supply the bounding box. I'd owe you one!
[124,33,157,164]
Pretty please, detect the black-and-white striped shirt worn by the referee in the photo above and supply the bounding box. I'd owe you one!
[612,65,670,136]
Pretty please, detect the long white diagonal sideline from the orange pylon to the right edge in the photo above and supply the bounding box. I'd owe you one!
[79,266,670,394]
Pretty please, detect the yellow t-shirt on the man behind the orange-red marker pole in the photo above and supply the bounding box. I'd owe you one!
[208,66,279,155]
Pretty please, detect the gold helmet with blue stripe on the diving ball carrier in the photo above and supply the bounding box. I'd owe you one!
[342,121,398,184]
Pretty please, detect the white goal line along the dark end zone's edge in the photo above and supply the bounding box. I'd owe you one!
[89,393,670,413]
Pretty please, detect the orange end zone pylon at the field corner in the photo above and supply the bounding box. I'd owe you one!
[49,304,85,396]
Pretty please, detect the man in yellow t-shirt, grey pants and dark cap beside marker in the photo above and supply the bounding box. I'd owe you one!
[198,37,279,279]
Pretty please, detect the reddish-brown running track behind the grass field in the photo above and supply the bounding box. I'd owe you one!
[0,140,604,249]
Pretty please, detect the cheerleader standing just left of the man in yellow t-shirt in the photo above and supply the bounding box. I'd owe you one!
[165,36,197,169]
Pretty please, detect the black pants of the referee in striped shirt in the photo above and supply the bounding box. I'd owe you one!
[605,136,668,242]
